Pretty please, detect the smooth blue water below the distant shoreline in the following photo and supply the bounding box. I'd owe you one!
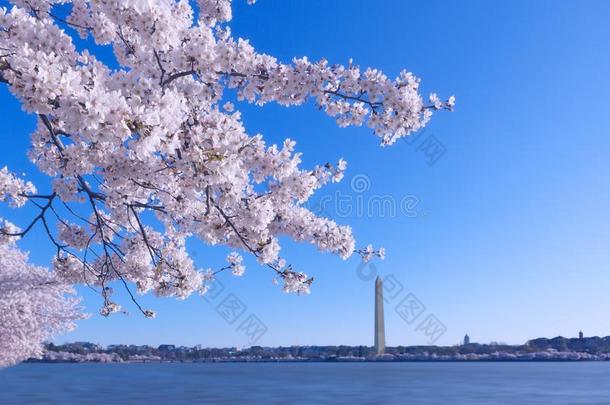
[0,362,610,405]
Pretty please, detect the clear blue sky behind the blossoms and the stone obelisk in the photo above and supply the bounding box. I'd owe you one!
[0,0,610,346]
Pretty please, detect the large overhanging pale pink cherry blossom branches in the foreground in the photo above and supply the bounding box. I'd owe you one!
[0,0,455,362]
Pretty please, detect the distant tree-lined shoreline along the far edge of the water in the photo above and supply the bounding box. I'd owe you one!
[28,336,610,363]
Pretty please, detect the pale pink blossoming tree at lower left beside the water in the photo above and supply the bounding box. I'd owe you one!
[0,232,83,368]
